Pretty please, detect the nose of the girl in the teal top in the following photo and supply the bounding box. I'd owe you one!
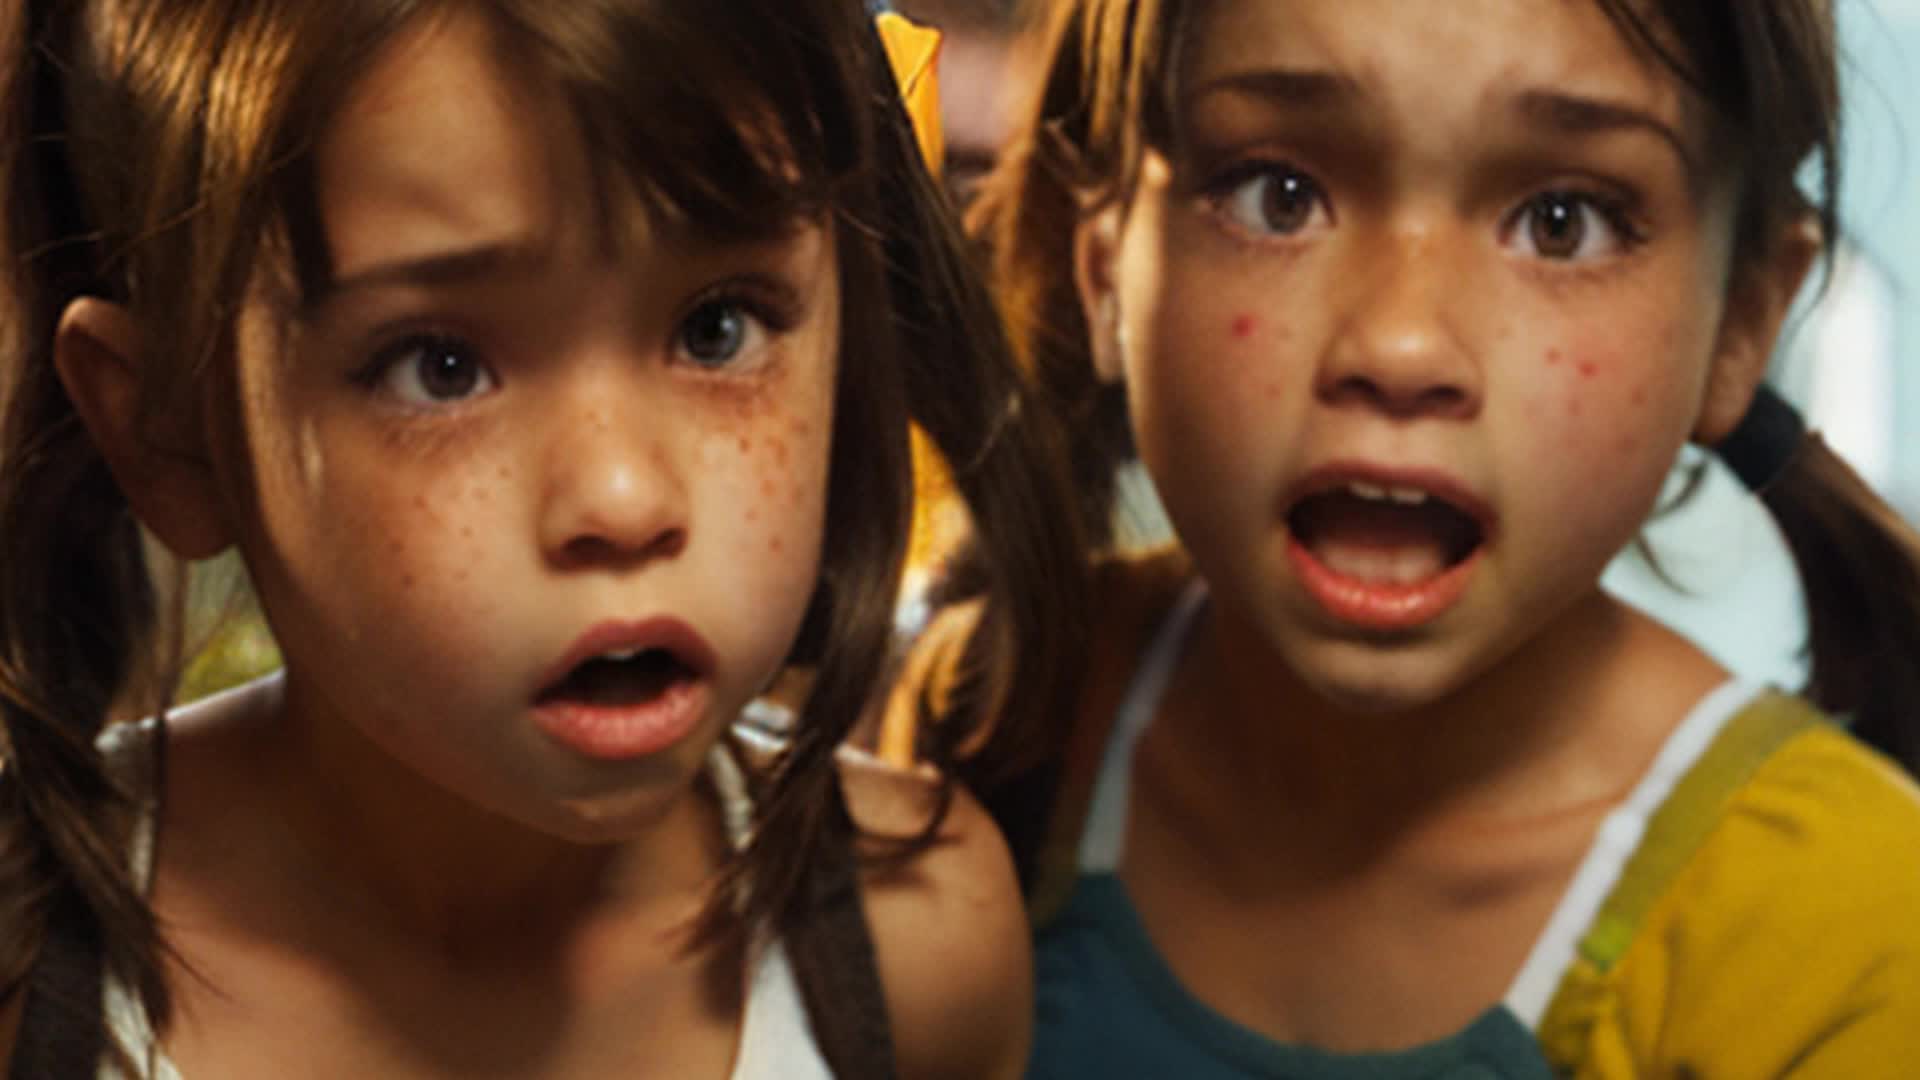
[1313,220,1482,419]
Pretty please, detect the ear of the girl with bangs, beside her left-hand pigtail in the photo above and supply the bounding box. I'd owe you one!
[54,296,232,559]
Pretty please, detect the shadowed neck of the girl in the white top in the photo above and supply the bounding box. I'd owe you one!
[271,673,726,967]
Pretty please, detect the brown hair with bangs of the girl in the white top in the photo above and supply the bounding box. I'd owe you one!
[0,0,1077,1045]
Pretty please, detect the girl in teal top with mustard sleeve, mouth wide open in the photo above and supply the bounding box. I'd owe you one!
[887,0,1920,1078]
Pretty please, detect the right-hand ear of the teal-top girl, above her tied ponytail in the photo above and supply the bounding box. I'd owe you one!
[1693,217,1820,446]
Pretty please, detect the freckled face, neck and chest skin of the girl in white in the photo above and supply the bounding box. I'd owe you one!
[129,19,839,1076]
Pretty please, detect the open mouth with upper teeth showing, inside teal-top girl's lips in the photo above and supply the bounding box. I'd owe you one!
[1286,482,1484,584]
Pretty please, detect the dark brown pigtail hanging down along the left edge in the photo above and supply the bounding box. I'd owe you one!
[0,4,165,1019]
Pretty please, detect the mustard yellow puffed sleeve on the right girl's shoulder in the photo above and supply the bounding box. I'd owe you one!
[1538,711,1920,1080]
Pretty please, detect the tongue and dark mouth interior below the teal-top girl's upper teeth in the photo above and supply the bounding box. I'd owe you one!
[1294,498,1452,584]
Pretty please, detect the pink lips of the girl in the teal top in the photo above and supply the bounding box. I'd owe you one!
[1284,463,1496,632]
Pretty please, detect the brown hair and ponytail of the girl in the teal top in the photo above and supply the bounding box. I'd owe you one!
[972,0,1920,773]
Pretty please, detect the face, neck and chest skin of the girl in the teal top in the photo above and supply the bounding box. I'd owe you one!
[1077,0,1805,1049]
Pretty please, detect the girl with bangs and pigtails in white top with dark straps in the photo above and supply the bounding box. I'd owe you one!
[0,0,1079,1080]
